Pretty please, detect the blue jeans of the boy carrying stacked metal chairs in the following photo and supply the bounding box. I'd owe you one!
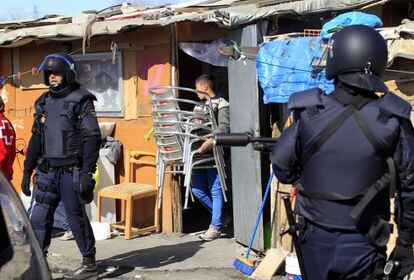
[191,168,223,229]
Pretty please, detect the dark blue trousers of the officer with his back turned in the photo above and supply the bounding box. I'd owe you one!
[302,224,381,280]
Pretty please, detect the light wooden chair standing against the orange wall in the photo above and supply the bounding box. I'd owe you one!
[98,149,159,239]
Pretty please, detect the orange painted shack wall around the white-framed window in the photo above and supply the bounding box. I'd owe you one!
[0,22,228,232]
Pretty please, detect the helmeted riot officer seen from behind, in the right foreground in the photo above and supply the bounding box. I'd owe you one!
[271,25,414,280]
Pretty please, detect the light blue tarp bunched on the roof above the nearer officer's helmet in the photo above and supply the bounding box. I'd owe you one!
[319,12,382,39]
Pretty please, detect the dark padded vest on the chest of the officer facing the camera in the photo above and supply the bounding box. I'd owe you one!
[33,89,96,159]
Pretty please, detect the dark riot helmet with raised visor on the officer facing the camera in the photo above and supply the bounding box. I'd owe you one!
[37,53,76,86]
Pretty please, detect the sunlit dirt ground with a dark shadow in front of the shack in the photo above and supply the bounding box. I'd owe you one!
[48,234,284,280]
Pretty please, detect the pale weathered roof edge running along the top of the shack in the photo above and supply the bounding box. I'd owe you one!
[0,0,381,47]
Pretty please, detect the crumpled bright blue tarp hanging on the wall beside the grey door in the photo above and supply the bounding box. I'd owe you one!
[256,37,334,104]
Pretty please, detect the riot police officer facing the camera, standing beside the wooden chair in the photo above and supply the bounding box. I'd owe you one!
[21,54,101,279]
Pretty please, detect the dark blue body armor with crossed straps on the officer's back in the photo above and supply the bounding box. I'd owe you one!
[289,89,411,230]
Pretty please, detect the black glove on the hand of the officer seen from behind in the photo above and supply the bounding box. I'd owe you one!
[390,238,414,279]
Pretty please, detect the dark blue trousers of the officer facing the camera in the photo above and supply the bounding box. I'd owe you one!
[31,168,96,257]
